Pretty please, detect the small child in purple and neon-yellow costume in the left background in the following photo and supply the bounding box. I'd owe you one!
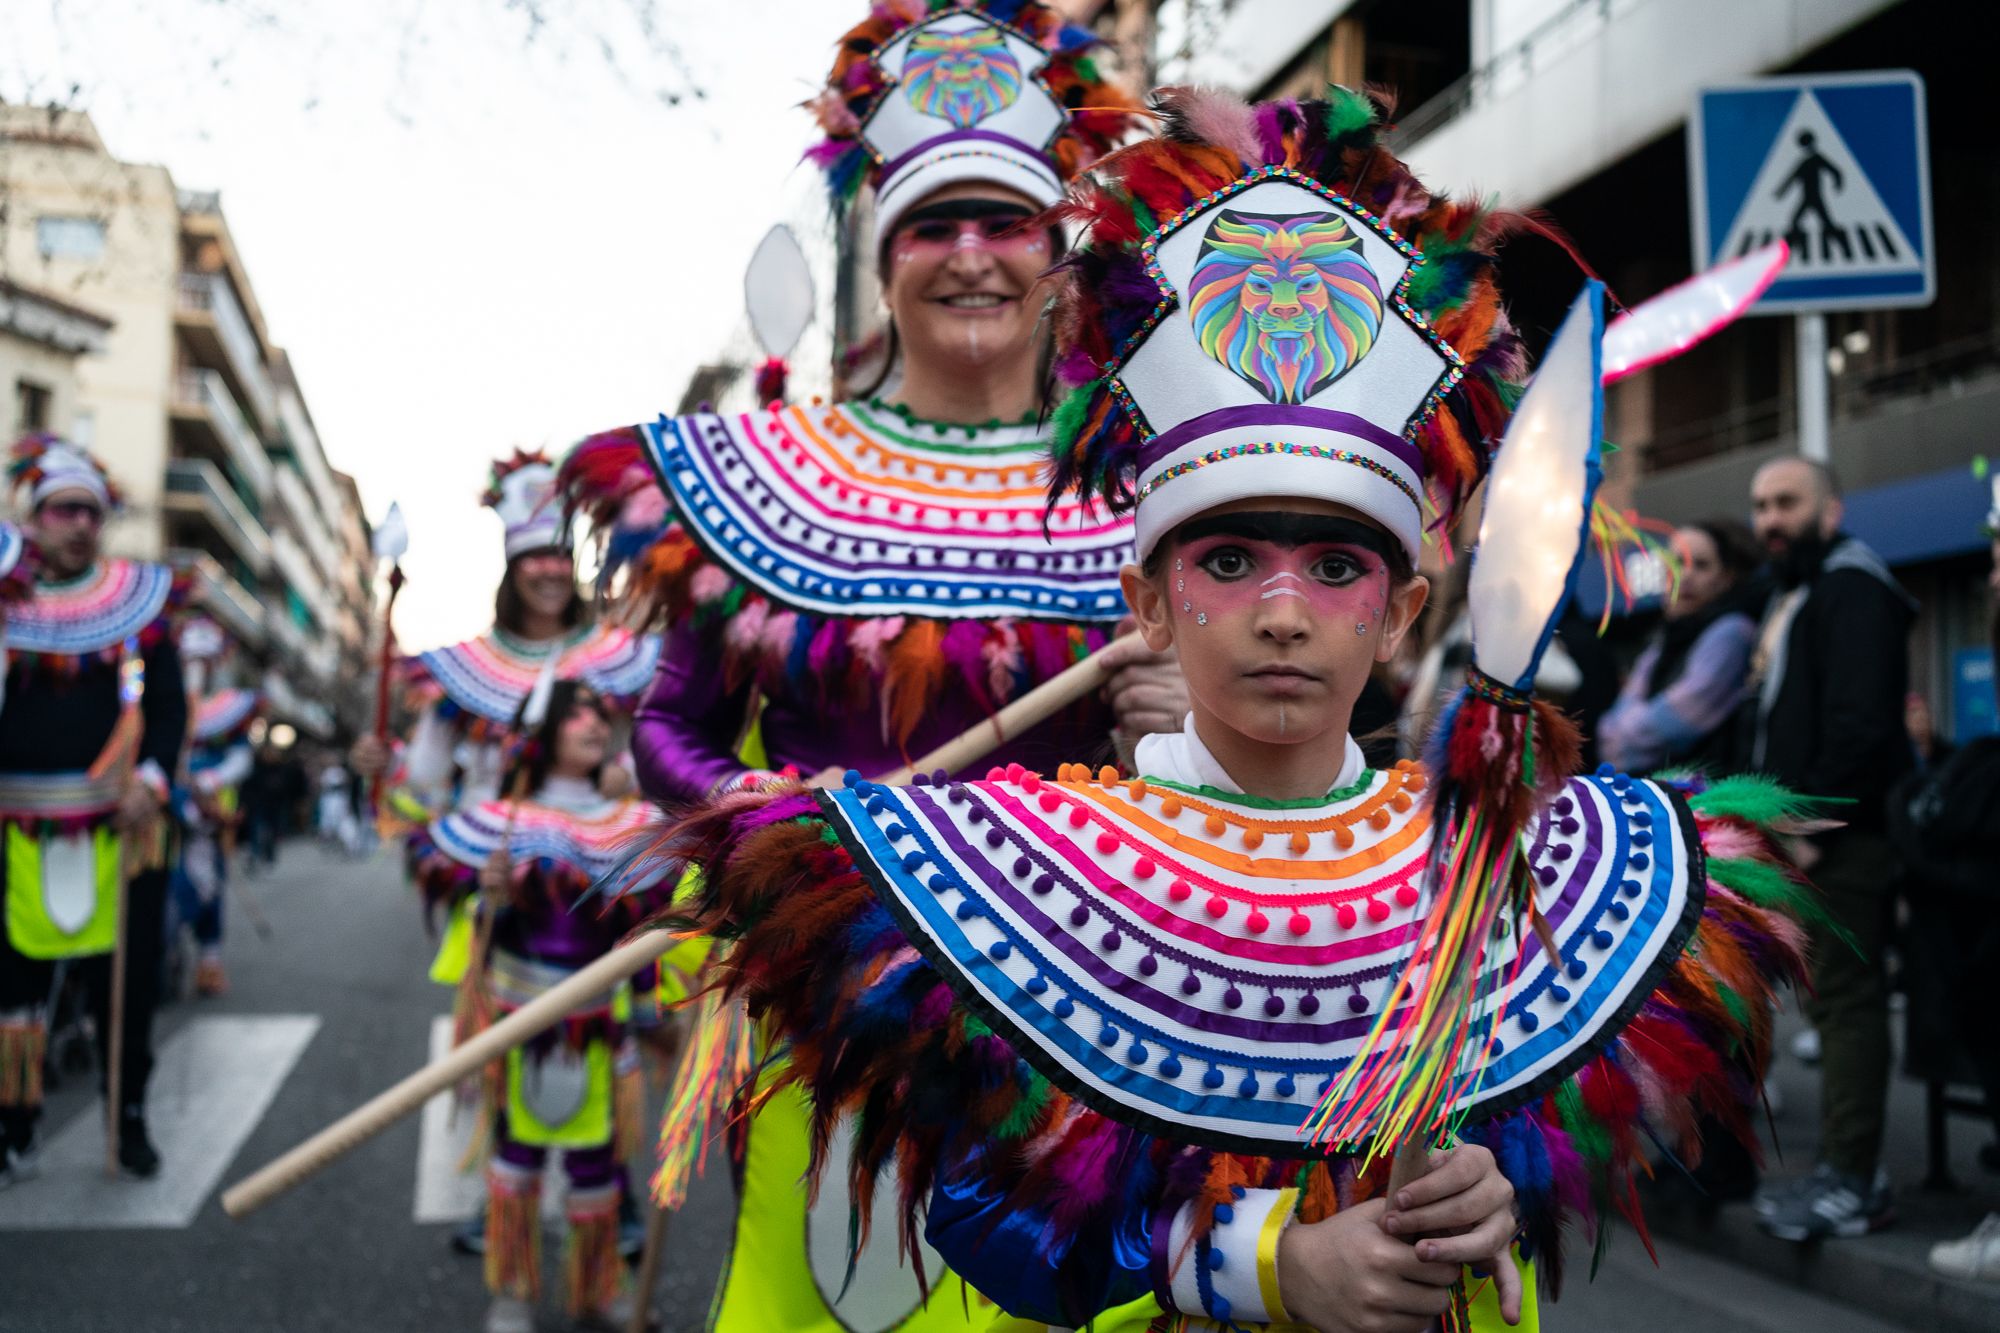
[410,681,684,1333]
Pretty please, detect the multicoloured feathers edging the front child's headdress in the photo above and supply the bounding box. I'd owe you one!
[1050,88,1520,536]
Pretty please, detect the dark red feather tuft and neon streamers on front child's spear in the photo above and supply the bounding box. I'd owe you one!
[1306,669,1582,1155]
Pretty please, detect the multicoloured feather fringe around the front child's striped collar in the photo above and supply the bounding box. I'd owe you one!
[636,763,1818,1323]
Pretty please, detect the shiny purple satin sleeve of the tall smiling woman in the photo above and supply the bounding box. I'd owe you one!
[632,624,748,805]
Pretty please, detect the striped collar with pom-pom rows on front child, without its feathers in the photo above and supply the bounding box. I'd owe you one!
[822,765,1702,1157]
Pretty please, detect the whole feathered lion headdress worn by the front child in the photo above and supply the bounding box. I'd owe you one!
[1052,88,1524,556]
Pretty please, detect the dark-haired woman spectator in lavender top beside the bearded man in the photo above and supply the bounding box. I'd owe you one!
[1598,518,1758,773]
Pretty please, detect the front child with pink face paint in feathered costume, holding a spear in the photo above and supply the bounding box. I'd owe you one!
[632,88,1808,1331]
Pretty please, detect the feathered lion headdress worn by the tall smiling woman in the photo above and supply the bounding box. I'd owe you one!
[806,0,1138,236]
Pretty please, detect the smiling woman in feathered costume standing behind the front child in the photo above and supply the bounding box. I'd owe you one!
[566,0,1186,1333]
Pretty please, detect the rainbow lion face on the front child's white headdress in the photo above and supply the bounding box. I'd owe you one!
[1188,210,1382,402]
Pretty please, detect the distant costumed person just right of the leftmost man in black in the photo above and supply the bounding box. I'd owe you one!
[174,616,260,995]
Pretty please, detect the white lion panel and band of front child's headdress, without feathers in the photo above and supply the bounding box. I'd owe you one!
[1112,166,1462,558]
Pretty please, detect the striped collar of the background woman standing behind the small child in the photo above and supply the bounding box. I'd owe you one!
[406,624,660,727]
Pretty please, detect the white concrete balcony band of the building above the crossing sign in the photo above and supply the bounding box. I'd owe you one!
[1390,0,1894,208]
